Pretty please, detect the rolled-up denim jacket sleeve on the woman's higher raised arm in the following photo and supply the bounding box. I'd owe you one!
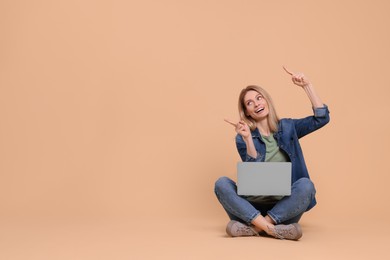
[293,105,330,138]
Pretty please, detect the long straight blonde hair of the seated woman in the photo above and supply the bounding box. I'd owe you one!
[238,85,279,133]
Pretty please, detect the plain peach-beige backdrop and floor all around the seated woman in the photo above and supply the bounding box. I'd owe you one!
[0,0,390,259]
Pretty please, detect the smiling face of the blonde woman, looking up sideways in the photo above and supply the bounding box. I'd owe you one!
[244,90,269,121]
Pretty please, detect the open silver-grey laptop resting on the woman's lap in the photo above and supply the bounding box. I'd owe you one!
[237,162,291,196]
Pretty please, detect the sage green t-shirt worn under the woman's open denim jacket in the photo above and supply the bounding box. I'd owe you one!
[245,134,289,204]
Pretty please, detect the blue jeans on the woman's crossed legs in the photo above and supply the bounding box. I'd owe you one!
[214,177,316,224]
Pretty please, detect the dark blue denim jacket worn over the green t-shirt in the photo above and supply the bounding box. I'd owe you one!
[236,105,330,210]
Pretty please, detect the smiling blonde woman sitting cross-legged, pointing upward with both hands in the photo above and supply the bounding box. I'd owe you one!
[215,67,329,240]
